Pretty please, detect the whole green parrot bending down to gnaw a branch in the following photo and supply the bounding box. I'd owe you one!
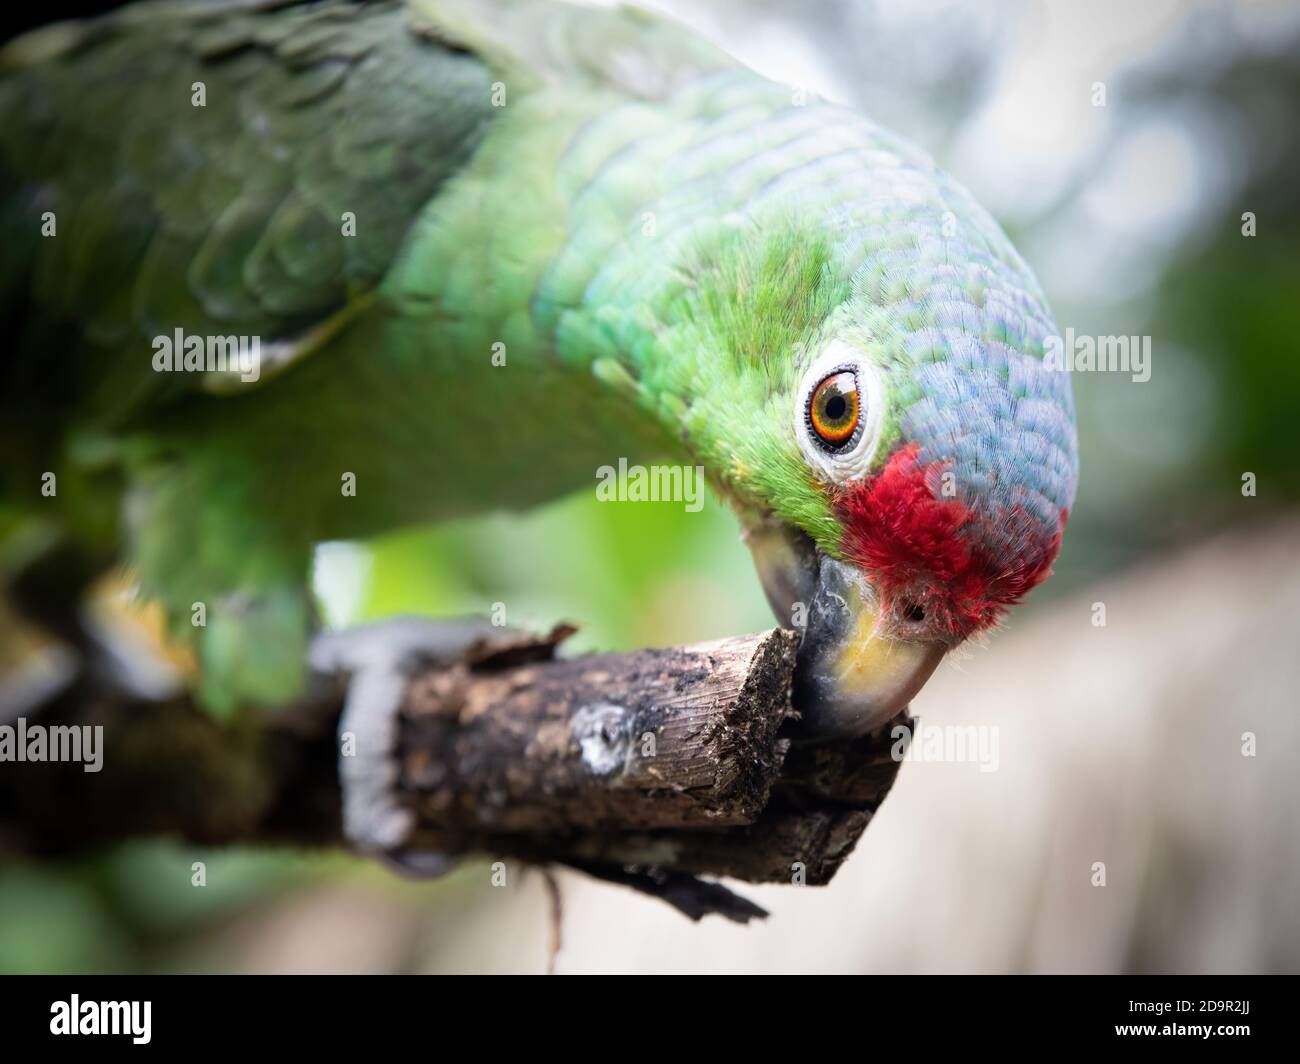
[0,0,1078,849]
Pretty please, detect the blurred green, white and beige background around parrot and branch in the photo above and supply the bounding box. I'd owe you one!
[0,0,1300,972]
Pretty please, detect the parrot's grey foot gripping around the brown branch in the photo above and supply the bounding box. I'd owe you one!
[309,617,508,878]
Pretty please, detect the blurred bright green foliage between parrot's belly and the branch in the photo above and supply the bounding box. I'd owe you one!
[354,479,771,649]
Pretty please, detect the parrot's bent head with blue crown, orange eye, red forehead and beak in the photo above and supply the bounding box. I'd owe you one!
[670,196,1078,738]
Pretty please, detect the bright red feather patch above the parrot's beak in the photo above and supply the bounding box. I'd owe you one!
[836,444,1067,641]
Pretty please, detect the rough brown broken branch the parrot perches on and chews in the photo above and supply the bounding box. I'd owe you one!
[0,628,898,920]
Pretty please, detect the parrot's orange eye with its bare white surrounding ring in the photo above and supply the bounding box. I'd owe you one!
[794,339,885,484]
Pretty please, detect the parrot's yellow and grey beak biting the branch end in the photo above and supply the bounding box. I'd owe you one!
[748,522,948,739]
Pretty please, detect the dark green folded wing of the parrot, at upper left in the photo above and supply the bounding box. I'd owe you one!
[0,3,493,431]
